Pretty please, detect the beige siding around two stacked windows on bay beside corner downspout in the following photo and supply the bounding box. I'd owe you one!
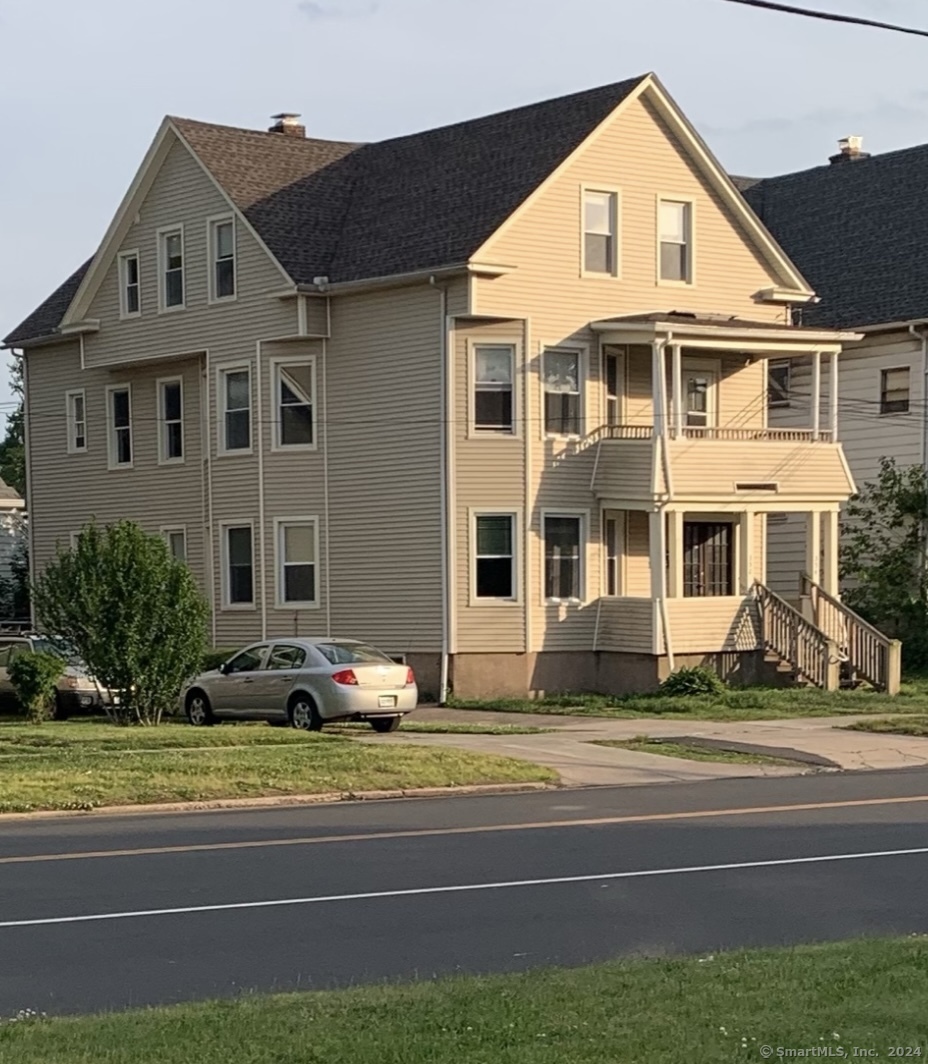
[454,320,525,653]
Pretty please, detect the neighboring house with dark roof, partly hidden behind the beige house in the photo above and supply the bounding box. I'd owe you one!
[734,137,928,598]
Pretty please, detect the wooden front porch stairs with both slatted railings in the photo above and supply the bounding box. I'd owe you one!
[755,575,901,695]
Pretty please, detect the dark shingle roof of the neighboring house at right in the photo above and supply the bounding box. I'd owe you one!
[742,145,928,328]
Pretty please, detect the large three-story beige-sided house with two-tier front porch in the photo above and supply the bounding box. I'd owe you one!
[5,74,897,698]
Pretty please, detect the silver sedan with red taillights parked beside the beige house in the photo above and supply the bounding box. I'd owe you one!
[181,638,419,732]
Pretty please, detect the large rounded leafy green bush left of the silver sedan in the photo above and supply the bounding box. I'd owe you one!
[33,520,209,725]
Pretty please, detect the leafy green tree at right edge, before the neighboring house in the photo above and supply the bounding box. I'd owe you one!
[841,458,928,668]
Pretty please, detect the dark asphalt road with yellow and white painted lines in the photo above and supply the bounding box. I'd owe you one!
[0,769,928,1017]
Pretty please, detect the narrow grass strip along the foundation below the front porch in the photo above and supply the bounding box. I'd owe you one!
[448,678,928,720]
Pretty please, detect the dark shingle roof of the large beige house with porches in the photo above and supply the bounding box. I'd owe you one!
[5,76,646,344]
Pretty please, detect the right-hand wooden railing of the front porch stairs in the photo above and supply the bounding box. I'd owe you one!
[799,572,902,695]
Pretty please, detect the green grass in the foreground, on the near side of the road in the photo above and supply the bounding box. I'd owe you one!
[0,937,928,1064]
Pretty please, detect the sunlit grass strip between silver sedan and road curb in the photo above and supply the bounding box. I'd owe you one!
[0,721,557,813]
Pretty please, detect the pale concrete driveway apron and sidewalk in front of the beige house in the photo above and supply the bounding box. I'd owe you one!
[361,706,928,786]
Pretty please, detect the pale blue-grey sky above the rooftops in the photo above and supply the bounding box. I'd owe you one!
[0,0,928,412]
